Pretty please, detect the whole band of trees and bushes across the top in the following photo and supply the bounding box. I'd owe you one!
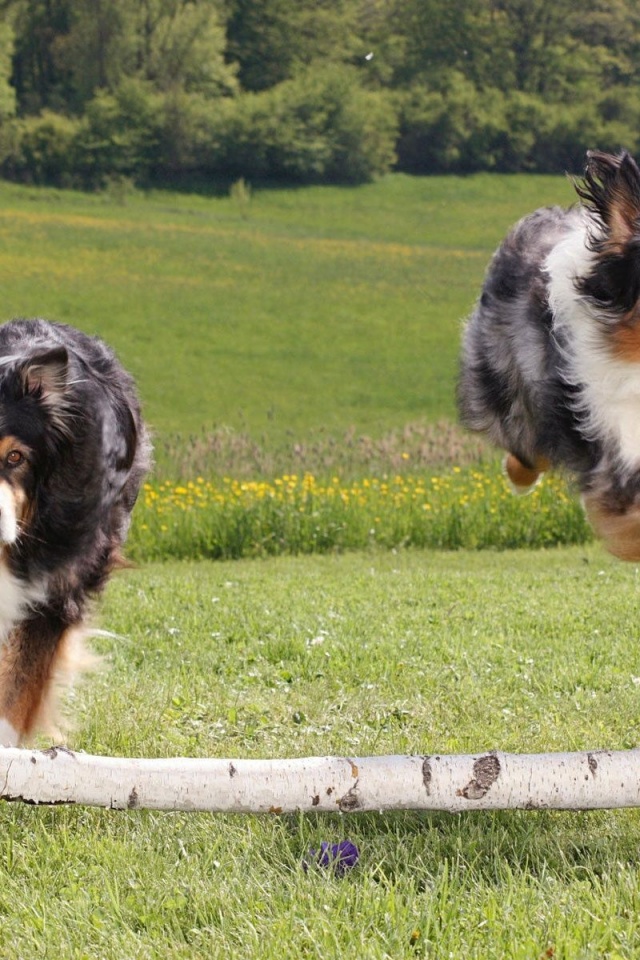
[0,0,640,188]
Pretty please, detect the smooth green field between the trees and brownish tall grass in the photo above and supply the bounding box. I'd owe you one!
[0,175,572,445]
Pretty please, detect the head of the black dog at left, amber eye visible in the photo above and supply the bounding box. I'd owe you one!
[0,347,71,546]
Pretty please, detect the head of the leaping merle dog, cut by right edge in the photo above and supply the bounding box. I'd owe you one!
[575,152,640,352]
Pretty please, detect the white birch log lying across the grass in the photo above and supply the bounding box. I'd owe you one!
[0,747,640,813]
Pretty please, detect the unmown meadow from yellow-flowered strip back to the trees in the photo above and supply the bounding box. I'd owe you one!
[0,175,589,561]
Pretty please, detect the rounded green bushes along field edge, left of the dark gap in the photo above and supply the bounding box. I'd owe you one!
[0,68,396,188]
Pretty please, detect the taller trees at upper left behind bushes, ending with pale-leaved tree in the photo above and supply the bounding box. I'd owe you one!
[10,0,236,113]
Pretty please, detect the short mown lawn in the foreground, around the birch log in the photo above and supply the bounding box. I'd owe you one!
[0,546,640,960]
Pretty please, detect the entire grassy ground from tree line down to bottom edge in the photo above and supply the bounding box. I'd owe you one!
[0,176,640,960]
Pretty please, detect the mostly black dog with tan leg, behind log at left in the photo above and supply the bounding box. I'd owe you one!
[0,319,151,746]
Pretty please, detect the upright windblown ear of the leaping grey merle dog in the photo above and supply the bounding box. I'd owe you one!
[576,150,640,249]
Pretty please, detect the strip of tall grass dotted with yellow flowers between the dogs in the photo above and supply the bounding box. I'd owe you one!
[129,455,591,560]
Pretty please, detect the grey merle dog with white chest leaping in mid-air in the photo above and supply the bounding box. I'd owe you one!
[458,146,640,561]
